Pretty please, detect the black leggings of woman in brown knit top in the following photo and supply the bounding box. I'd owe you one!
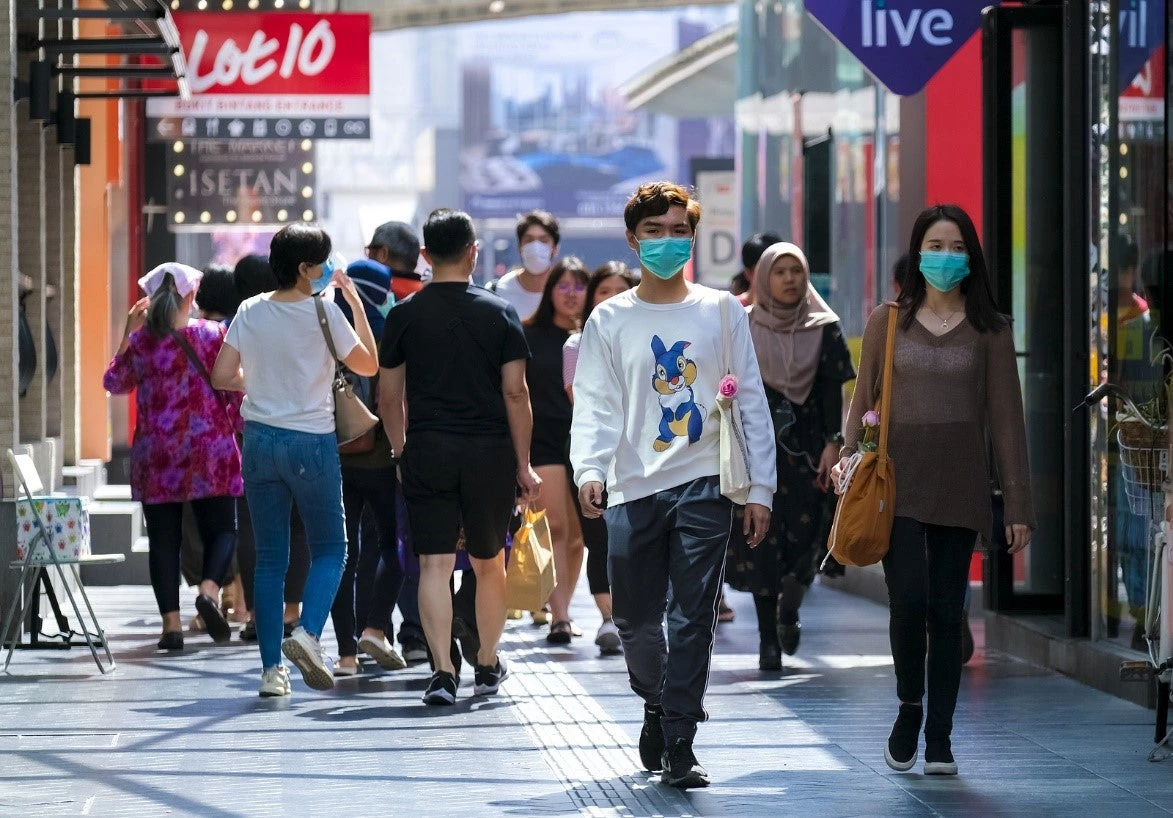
[883,516,977,741]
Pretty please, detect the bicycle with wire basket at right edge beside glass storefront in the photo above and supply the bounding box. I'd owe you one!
[1083,384,1173,762]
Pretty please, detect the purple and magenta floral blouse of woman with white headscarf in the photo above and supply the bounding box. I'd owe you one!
[102,320,244,503]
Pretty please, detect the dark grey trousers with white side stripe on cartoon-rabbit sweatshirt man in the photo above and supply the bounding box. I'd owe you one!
[605,476,733,745]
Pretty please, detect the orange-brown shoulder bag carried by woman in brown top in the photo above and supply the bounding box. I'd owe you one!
[823,304,900,566]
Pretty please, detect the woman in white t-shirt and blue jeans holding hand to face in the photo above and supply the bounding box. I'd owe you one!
[212,224,379,696]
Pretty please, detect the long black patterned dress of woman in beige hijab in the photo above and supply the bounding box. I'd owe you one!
[725,323,855,596]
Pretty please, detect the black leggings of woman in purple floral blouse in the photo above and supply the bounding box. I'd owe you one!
[143,496,236,614]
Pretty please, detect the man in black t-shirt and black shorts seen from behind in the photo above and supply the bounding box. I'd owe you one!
[379,209,542,704]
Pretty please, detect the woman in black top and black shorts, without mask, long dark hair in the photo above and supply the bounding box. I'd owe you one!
[524,256,589,644]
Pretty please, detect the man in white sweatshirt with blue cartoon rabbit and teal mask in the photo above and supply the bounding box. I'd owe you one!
[570,182,777,787]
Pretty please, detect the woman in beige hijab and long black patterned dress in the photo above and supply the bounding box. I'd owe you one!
[726,242,855,670]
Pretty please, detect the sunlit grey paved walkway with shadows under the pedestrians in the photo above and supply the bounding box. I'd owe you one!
[0,577,1173,818]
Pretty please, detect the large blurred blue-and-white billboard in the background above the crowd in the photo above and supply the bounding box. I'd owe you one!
[456,12,722,218]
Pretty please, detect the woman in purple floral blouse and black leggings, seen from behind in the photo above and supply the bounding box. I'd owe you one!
[102,263,244,650]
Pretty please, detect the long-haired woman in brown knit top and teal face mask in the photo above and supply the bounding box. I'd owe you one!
[832,204,1035,775]
